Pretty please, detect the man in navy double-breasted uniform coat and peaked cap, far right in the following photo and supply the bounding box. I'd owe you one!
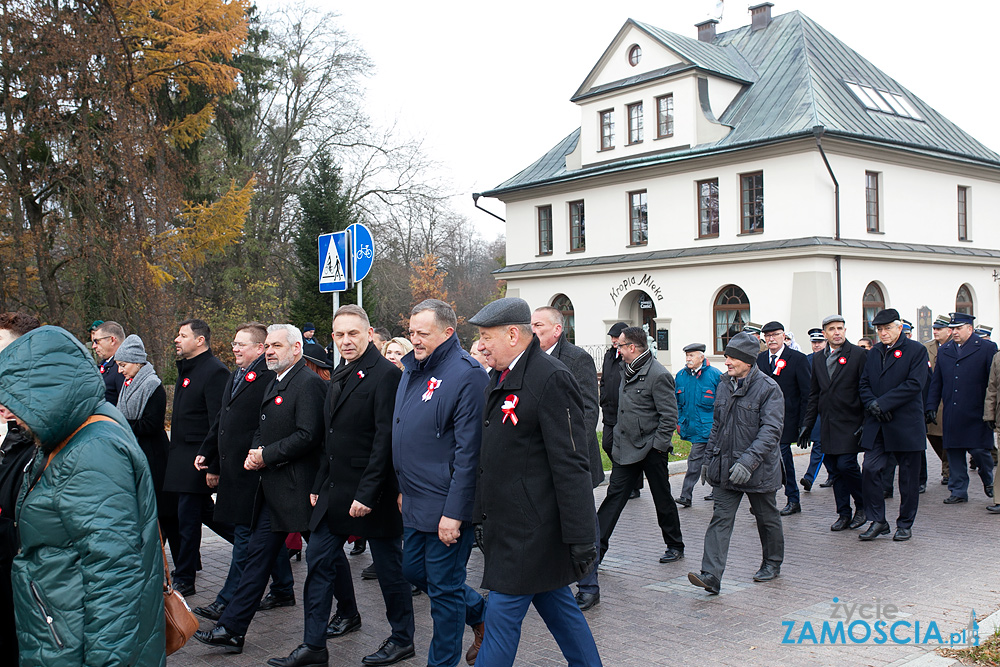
[924,313,997,505]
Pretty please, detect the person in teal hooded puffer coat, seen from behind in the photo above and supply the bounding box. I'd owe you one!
[0,327,166,667]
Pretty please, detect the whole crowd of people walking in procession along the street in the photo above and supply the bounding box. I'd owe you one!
[0,298,1000,667]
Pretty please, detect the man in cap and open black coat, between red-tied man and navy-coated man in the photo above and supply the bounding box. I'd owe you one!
[798,315,868,531]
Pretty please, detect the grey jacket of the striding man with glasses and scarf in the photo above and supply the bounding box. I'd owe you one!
[611,357,677,465]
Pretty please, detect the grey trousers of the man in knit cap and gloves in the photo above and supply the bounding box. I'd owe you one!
[701,486,785,581]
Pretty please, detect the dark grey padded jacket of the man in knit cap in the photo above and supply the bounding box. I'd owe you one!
[705,366,785,493]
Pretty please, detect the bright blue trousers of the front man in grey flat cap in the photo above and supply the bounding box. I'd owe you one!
[476,586,602,667]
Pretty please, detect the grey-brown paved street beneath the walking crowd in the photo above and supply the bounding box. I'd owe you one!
[168,452,1000,667]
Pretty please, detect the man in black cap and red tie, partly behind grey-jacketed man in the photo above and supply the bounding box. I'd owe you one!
[757,322,809,516]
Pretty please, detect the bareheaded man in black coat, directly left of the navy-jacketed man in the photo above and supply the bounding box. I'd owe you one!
[268,305,414,667]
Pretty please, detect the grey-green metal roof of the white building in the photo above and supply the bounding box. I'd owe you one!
[483,11,1000,196]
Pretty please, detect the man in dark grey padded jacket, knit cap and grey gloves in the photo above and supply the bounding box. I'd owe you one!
[688,333,785,595]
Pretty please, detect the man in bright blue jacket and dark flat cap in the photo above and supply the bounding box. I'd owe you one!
[674,343,722,507]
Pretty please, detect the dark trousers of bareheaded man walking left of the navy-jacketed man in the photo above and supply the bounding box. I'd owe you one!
[302,519,413,647]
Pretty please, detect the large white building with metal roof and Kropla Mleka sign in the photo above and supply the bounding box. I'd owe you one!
[482,3,1000,371]
